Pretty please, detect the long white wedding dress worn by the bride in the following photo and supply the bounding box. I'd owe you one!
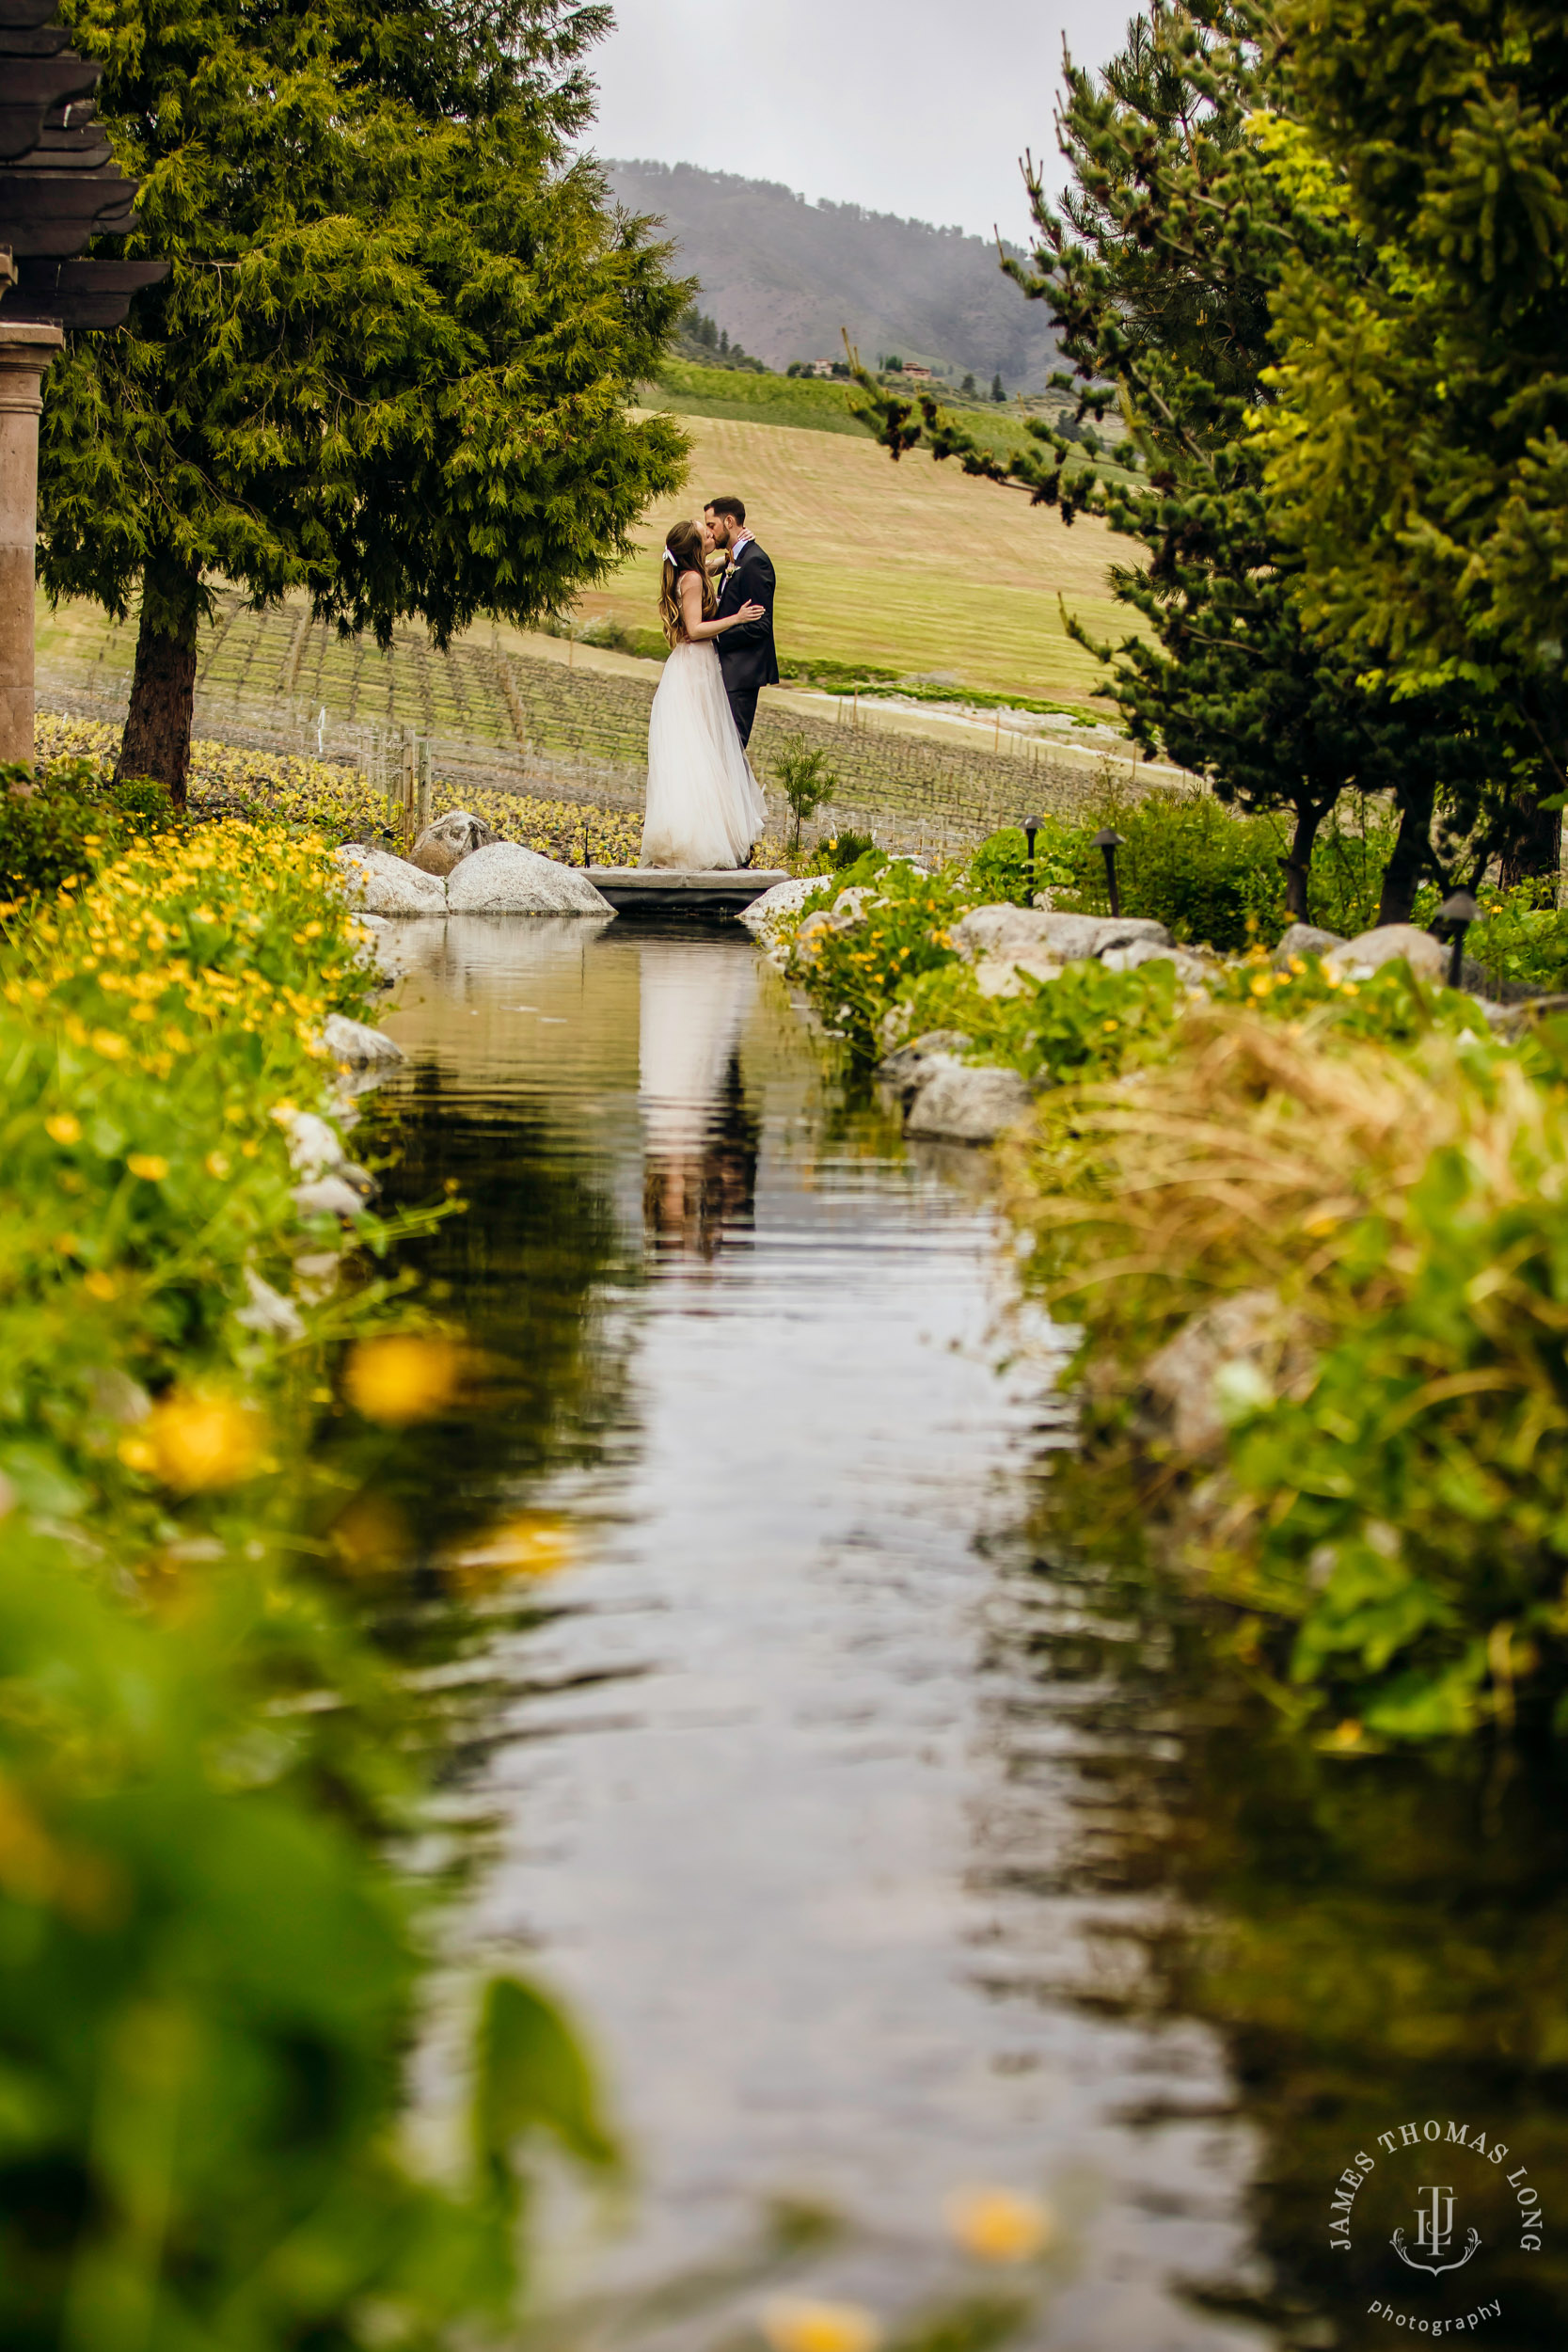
[637,638,768,873]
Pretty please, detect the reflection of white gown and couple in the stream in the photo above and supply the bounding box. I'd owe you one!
[640,941,757,1259]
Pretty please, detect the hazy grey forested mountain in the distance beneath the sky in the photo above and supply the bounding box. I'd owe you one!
[607,163,1055,393]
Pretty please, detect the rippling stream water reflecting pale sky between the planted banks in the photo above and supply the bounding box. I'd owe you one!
[376,917,1568,2352]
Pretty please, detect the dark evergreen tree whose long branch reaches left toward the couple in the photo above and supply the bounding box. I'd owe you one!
[850,0,1514,922]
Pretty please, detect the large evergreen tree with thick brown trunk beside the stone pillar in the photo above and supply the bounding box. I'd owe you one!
[40,0,691,795]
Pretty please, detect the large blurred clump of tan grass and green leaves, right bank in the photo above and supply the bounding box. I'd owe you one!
[1013,1011,1568,1743]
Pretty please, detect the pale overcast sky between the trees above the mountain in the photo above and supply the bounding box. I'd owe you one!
[593,0,1133,243]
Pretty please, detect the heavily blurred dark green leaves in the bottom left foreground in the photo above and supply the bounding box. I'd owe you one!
[0,1527,604,2352]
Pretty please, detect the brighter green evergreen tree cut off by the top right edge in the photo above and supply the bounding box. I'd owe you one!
[1267,0,1568,875]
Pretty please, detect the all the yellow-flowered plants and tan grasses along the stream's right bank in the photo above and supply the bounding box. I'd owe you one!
[790,804,1568,1748]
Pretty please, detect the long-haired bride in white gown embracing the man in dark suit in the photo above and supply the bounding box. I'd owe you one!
[637,522,767,873]
